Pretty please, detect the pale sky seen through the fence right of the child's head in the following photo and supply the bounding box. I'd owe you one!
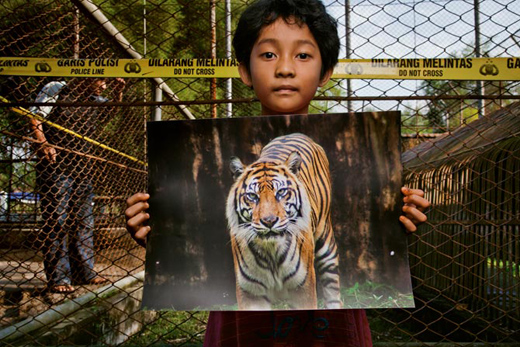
[324,0,520,109]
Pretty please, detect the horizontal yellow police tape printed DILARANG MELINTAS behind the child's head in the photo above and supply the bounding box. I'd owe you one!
[0,57,520,81]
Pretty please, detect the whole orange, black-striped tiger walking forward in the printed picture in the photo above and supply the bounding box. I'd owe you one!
[226,133,342,310]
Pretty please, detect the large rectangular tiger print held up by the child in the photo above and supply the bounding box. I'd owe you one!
[142,111,414,311]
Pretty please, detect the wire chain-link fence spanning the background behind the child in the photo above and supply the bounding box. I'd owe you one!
[0,0,520,346]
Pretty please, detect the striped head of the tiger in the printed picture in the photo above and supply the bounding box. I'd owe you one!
[227,152,310,243]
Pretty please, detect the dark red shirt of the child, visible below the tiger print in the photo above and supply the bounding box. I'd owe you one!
[204,310,372,347]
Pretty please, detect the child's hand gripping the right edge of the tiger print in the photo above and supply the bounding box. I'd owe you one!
[399,187,430,233]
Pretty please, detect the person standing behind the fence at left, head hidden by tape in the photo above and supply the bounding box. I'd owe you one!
[31,79,125,293]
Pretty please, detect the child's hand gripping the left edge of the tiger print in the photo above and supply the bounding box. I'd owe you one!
[125,193,150,247]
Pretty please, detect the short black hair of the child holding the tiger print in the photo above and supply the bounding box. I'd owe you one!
[233,0,339,76]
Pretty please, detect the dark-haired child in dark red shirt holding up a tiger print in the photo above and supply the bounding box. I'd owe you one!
[125,0,429,347]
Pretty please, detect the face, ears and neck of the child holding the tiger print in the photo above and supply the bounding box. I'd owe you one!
[239,18,332,115]
